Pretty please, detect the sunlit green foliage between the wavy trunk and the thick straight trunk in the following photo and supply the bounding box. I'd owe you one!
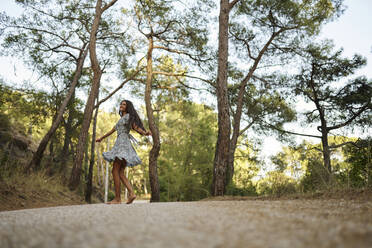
[158,101,216,201]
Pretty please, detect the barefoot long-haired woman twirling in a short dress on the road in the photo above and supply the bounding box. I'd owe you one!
[96,100,151,204]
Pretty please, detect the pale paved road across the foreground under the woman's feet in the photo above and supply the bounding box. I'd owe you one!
[0,200,372,248]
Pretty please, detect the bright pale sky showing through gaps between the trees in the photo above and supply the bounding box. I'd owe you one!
[0,0,372,156]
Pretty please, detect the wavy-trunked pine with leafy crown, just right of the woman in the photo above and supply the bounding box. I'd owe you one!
[134,0,211,201]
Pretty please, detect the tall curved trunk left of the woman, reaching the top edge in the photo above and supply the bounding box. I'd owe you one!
[69,0,117,190]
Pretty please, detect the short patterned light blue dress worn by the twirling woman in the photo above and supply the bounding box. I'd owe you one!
[102,113,142,166]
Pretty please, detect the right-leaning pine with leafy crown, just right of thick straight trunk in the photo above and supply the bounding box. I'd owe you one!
[227,0,342,187]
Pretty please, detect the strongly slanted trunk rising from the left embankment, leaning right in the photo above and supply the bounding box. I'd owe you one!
[26,44,88,171]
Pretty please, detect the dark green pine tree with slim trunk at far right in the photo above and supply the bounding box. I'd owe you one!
[293,42,372,180]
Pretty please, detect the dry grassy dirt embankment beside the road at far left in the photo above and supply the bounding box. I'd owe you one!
[0,127,88,211]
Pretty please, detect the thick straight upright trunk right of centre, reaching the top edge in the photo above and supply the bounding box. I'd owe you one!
[212,0,230,196]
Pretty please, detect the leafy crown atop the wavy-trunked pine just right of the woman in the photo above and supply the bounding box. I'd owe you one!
[130,0,209,72]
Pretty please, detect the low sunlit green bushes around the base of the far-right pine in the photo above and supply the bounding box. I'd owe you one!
[270,136,372,192]
